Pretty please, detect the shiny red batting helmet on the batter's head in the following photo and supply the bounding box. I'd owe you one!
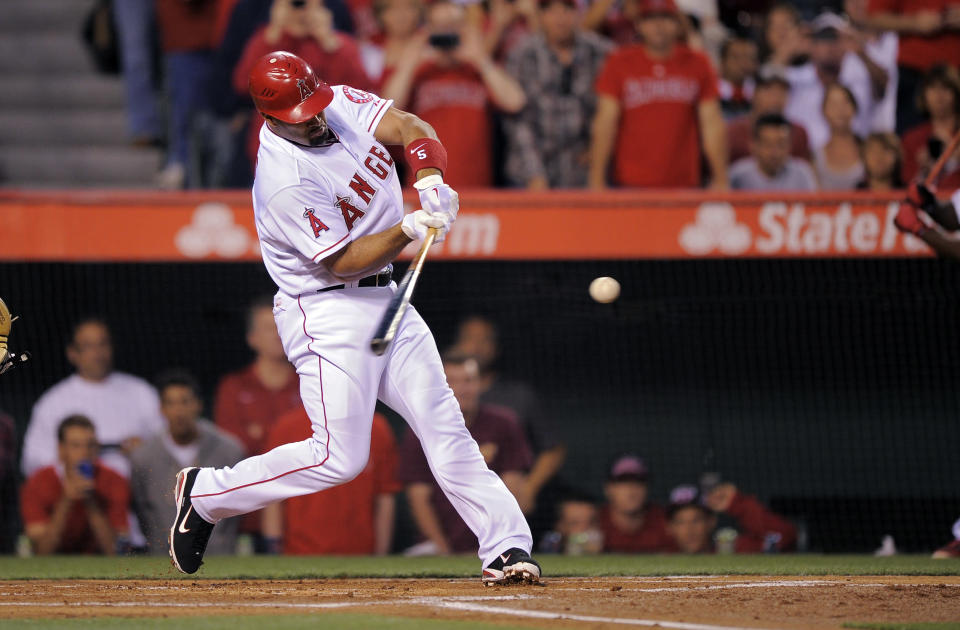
[250,50,333,123]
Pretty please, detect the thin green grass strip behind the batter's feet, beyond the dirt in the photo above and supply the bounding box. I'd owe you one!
[0,554,960,580]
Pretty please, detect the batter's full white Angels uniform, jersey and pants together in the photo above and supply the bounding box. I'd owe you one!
[190,86,532,566]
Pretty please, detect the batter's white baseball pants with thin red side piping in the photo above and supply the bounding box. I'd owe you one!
[191,283,532,566]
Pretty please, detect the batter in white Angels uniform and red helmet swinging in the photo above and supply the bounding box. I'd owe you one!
[170,51,540,584]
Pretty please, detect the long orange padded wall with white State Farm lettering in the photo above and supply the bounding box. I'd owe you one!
[0,191,930,261]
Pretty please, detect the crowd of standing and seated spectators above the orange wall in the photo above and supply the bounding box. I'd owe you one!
[114,0,960,191]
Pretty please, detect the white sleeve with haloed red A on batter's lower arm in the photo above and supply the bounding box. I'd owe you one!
[267,182,350,263]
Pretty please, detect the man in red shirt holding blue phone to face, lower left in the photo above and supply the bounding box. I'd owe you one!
[20,415,130,555]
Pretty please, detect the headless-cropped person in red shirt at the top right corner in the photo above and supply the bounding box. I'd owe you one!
[869,0,960,133]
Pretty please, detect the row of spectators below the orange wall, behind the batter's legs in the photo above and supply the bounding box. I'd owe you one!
[0,308,820,555]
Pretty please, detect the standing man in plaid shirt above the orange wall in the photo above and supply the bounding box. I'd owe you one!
[504,0,613,189]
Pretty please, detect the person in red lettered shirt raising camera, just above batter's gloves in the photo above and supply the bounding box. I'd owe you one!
[381,0,526,190]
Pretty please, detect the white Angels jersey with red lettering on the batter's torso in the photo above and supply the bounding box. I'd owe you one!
[253,85,403,295]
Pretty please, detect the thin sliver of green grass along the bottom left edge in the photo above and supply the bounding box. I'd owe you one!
[3,613,529,630]
